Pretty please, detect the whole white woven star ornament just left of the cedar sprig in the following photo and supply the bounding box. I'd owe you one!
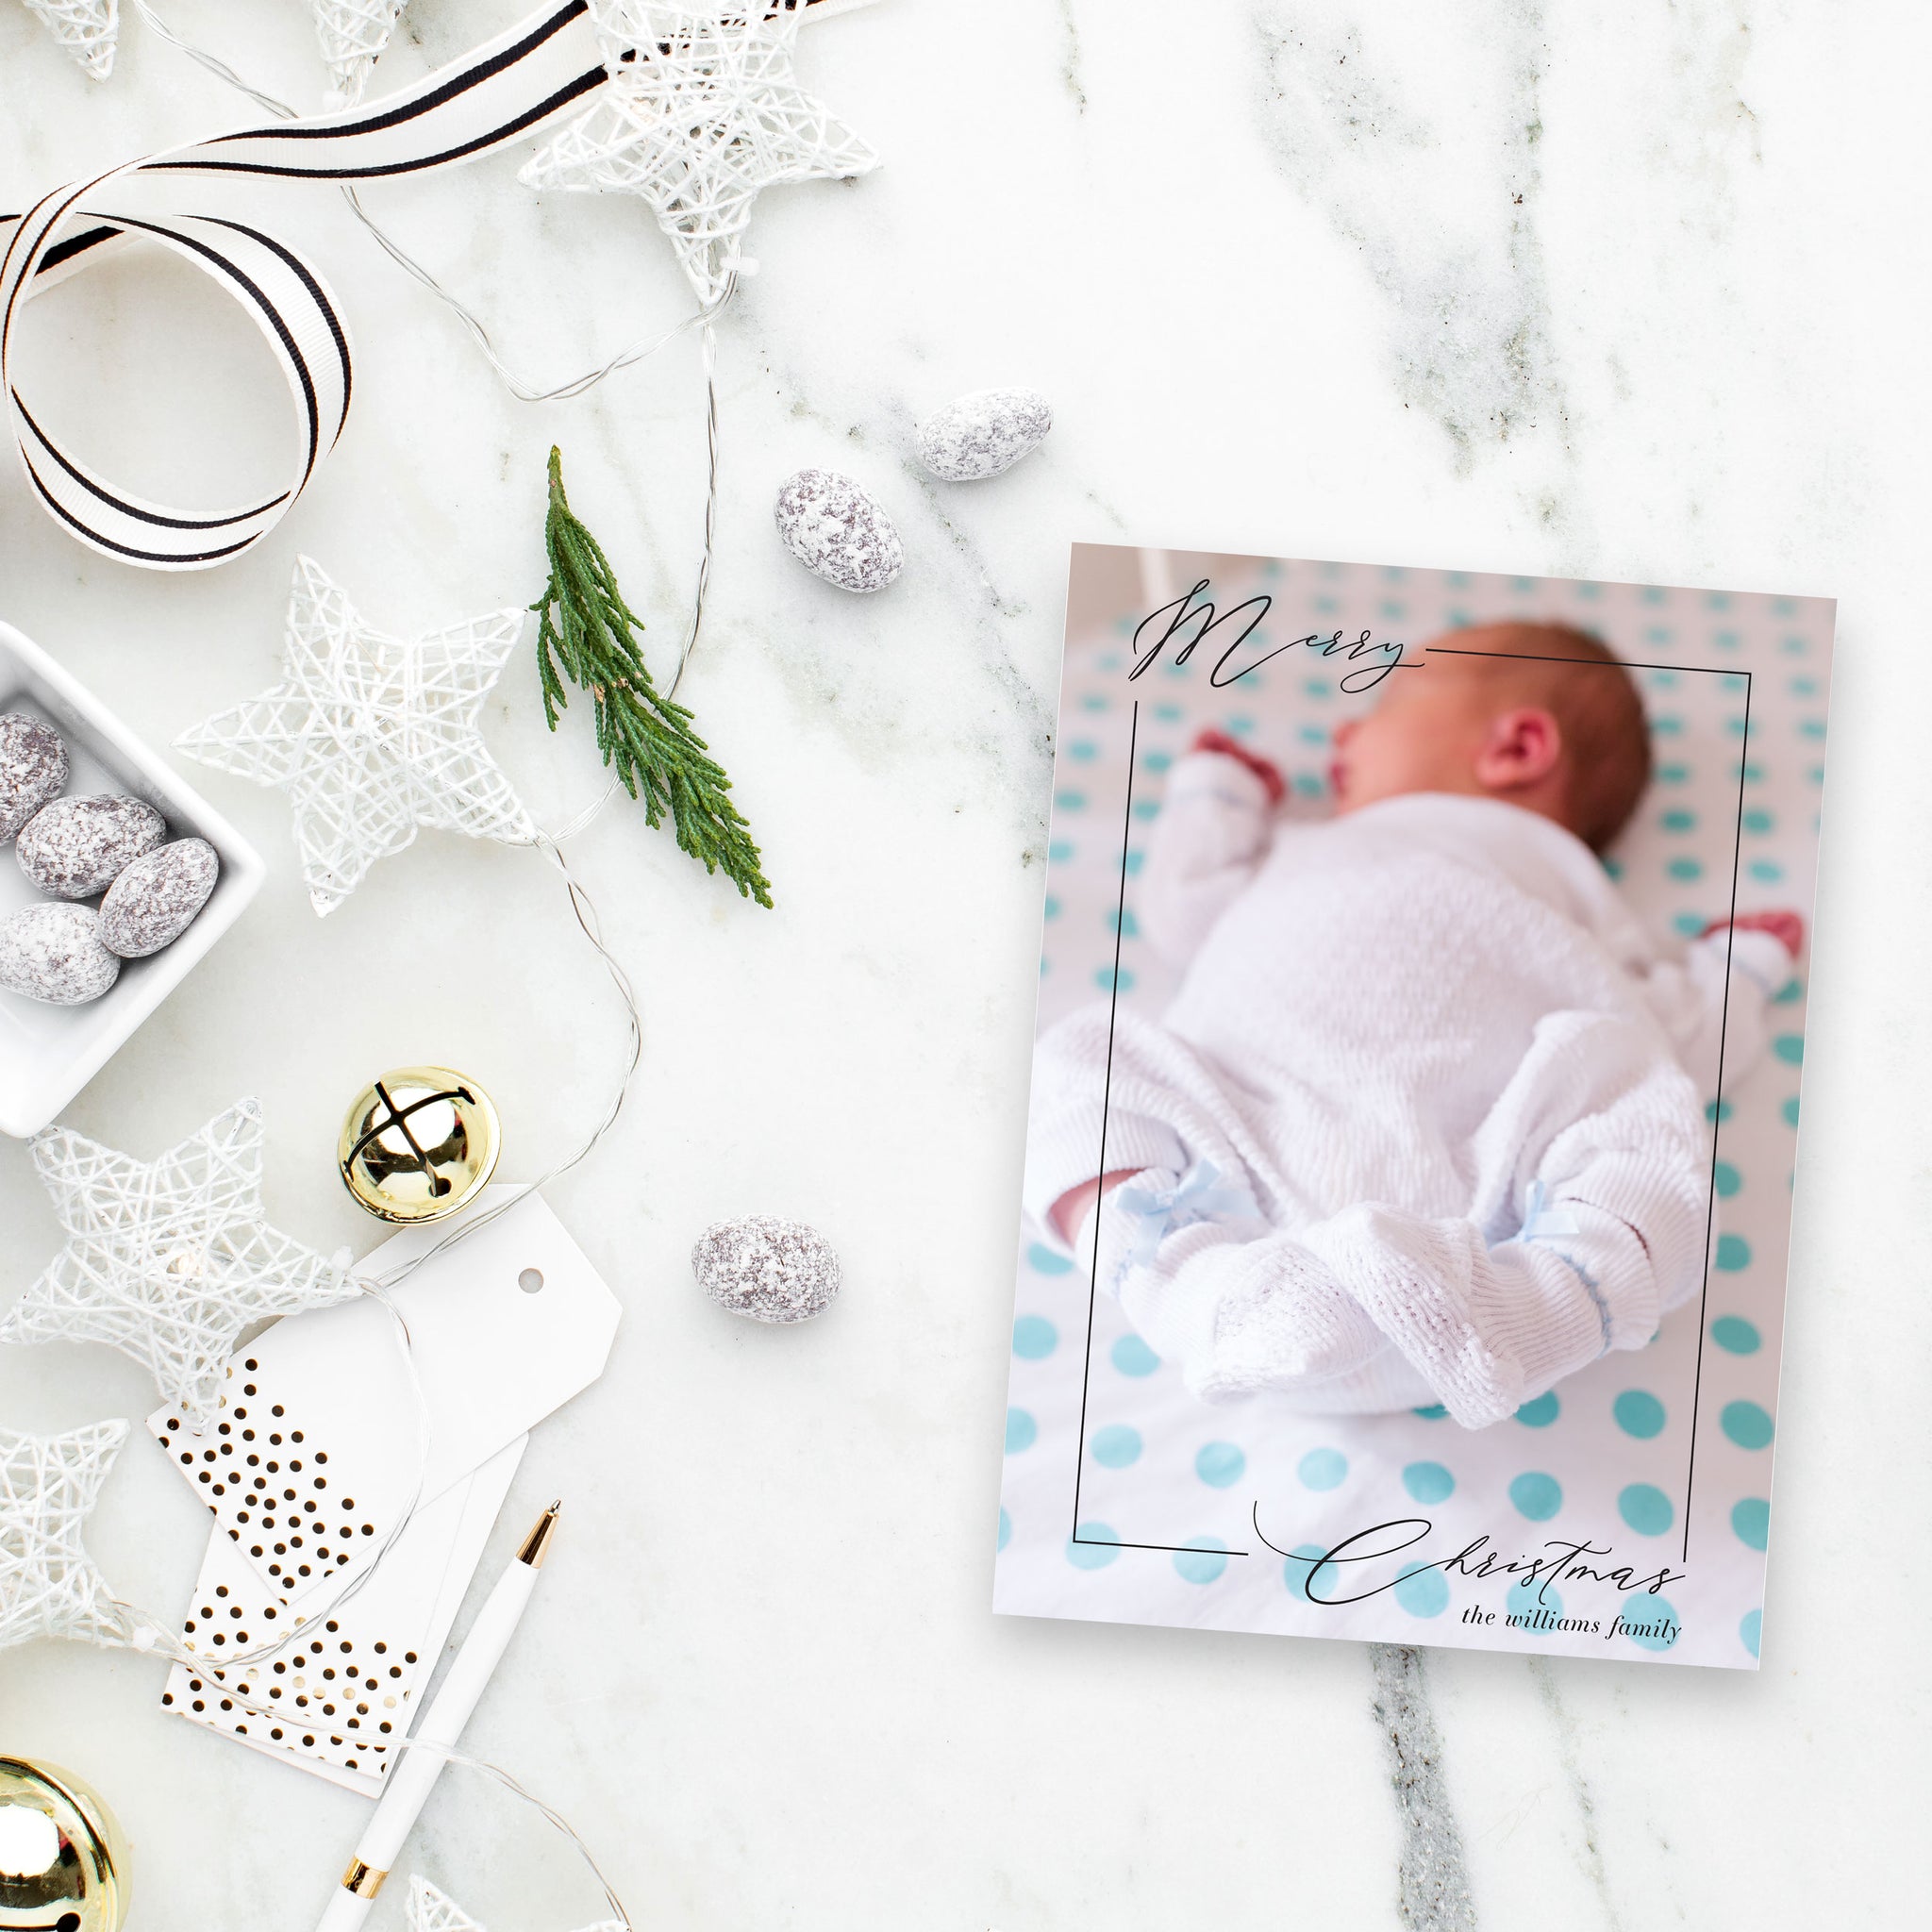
[174,557,535,914]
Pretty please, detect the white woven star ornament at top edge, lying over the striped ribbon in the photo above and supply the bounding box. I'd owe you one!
[520,0,879,306]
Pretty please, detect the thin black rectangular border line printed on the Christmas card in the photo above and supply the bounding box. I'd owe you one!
[1069,629,1757,1563]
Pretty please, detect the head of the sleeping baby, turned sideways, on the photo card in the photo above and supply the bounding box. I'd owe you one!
[1331,625,1650,852]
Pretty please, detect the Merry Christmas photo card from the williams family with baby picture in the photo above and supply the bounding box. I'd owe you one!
[995,545,1834,1669]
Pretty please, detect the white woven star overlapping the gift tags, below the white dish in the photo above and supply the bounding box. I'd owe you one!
[0,1099,361,1434]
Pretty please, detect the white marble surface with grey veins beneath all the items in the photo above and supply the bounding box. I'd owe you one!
[0,0,1932,1932]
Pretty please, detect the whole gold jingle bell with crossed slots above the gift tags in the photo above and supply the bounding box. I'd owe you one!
[336,1066,502,1221]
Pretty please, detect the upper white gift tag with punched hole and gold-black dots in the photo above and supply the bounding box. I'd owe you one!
[149,1189,620,1609]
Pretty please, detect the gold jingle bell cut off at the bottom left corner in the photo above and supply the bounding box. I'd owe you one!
[0,1758,127,1932]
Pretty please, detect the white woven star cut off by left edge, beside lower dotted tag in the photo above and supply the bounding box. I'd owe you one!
[0,1422,147,1650]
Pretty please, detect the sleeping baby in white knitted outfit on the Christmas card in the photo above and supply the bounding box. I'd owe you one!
[1025,625,1803,1427]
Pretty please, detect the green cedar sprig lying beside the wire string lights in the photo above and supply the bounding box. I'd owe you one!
[529,448,771,907]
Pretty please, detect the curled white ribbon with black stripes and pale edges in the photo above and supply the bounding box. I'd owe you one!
[0,0,869,570]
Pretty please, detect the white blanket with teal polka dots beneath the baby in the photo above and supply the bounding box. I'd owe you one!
[995,545,1834,1669]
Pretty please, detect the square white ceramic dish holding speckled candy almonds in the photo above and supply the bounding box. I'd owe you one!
[0,625,263,1138]
